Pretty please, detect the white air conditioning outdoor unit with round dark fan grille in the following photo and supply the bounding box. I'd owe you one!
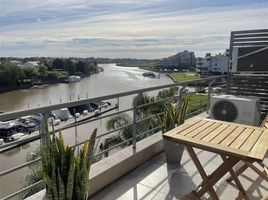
[210,95,260,126]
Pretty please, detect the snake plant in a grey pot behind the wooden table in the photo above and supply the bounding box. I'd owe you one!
[157,97,189,166]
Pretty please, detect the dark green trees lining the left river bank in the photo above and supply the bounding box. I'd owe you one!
[0,58,97,88]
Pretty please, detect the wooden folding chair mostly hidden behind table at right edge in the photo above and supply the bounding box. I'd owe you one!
[226,115,268,182]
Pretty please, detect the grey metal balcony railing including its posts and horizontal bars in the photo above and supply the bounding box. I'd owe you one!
[0,76,227,200]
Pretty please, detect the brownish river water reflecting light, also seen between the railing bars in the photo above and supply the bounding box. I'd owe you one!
[0,64,172,198]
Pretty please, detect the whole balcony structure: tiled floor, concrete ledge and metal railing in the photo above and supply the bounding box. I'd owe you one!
[0,76,268,200]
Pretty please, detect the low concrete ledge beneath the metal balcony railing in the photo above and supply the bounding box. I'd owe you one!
[27,132,164,200]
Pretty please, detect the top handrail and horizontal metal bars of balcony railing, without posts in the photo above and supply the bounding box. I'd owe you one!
[0,75,227,199]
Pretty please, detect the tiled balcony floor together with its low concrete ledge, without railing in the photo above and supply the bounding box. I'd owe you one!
[27,123,268,200]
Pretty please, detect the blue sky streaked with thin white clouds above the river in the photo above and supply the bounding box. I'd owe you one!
[0,0,268,59]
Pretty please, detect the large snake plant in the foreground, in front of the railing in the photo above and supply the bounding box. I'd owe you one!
[41,122,97,200]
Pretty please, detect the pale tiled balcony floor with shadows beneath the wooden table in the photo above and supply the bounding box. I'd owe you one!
[90,149,268,200]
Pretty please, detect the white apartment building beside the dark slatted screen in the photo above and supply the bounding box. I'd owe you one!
[196,53,229,75]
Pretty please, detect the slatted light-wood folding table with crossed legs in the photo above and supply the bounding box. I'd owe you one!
[164,117,268,199]
